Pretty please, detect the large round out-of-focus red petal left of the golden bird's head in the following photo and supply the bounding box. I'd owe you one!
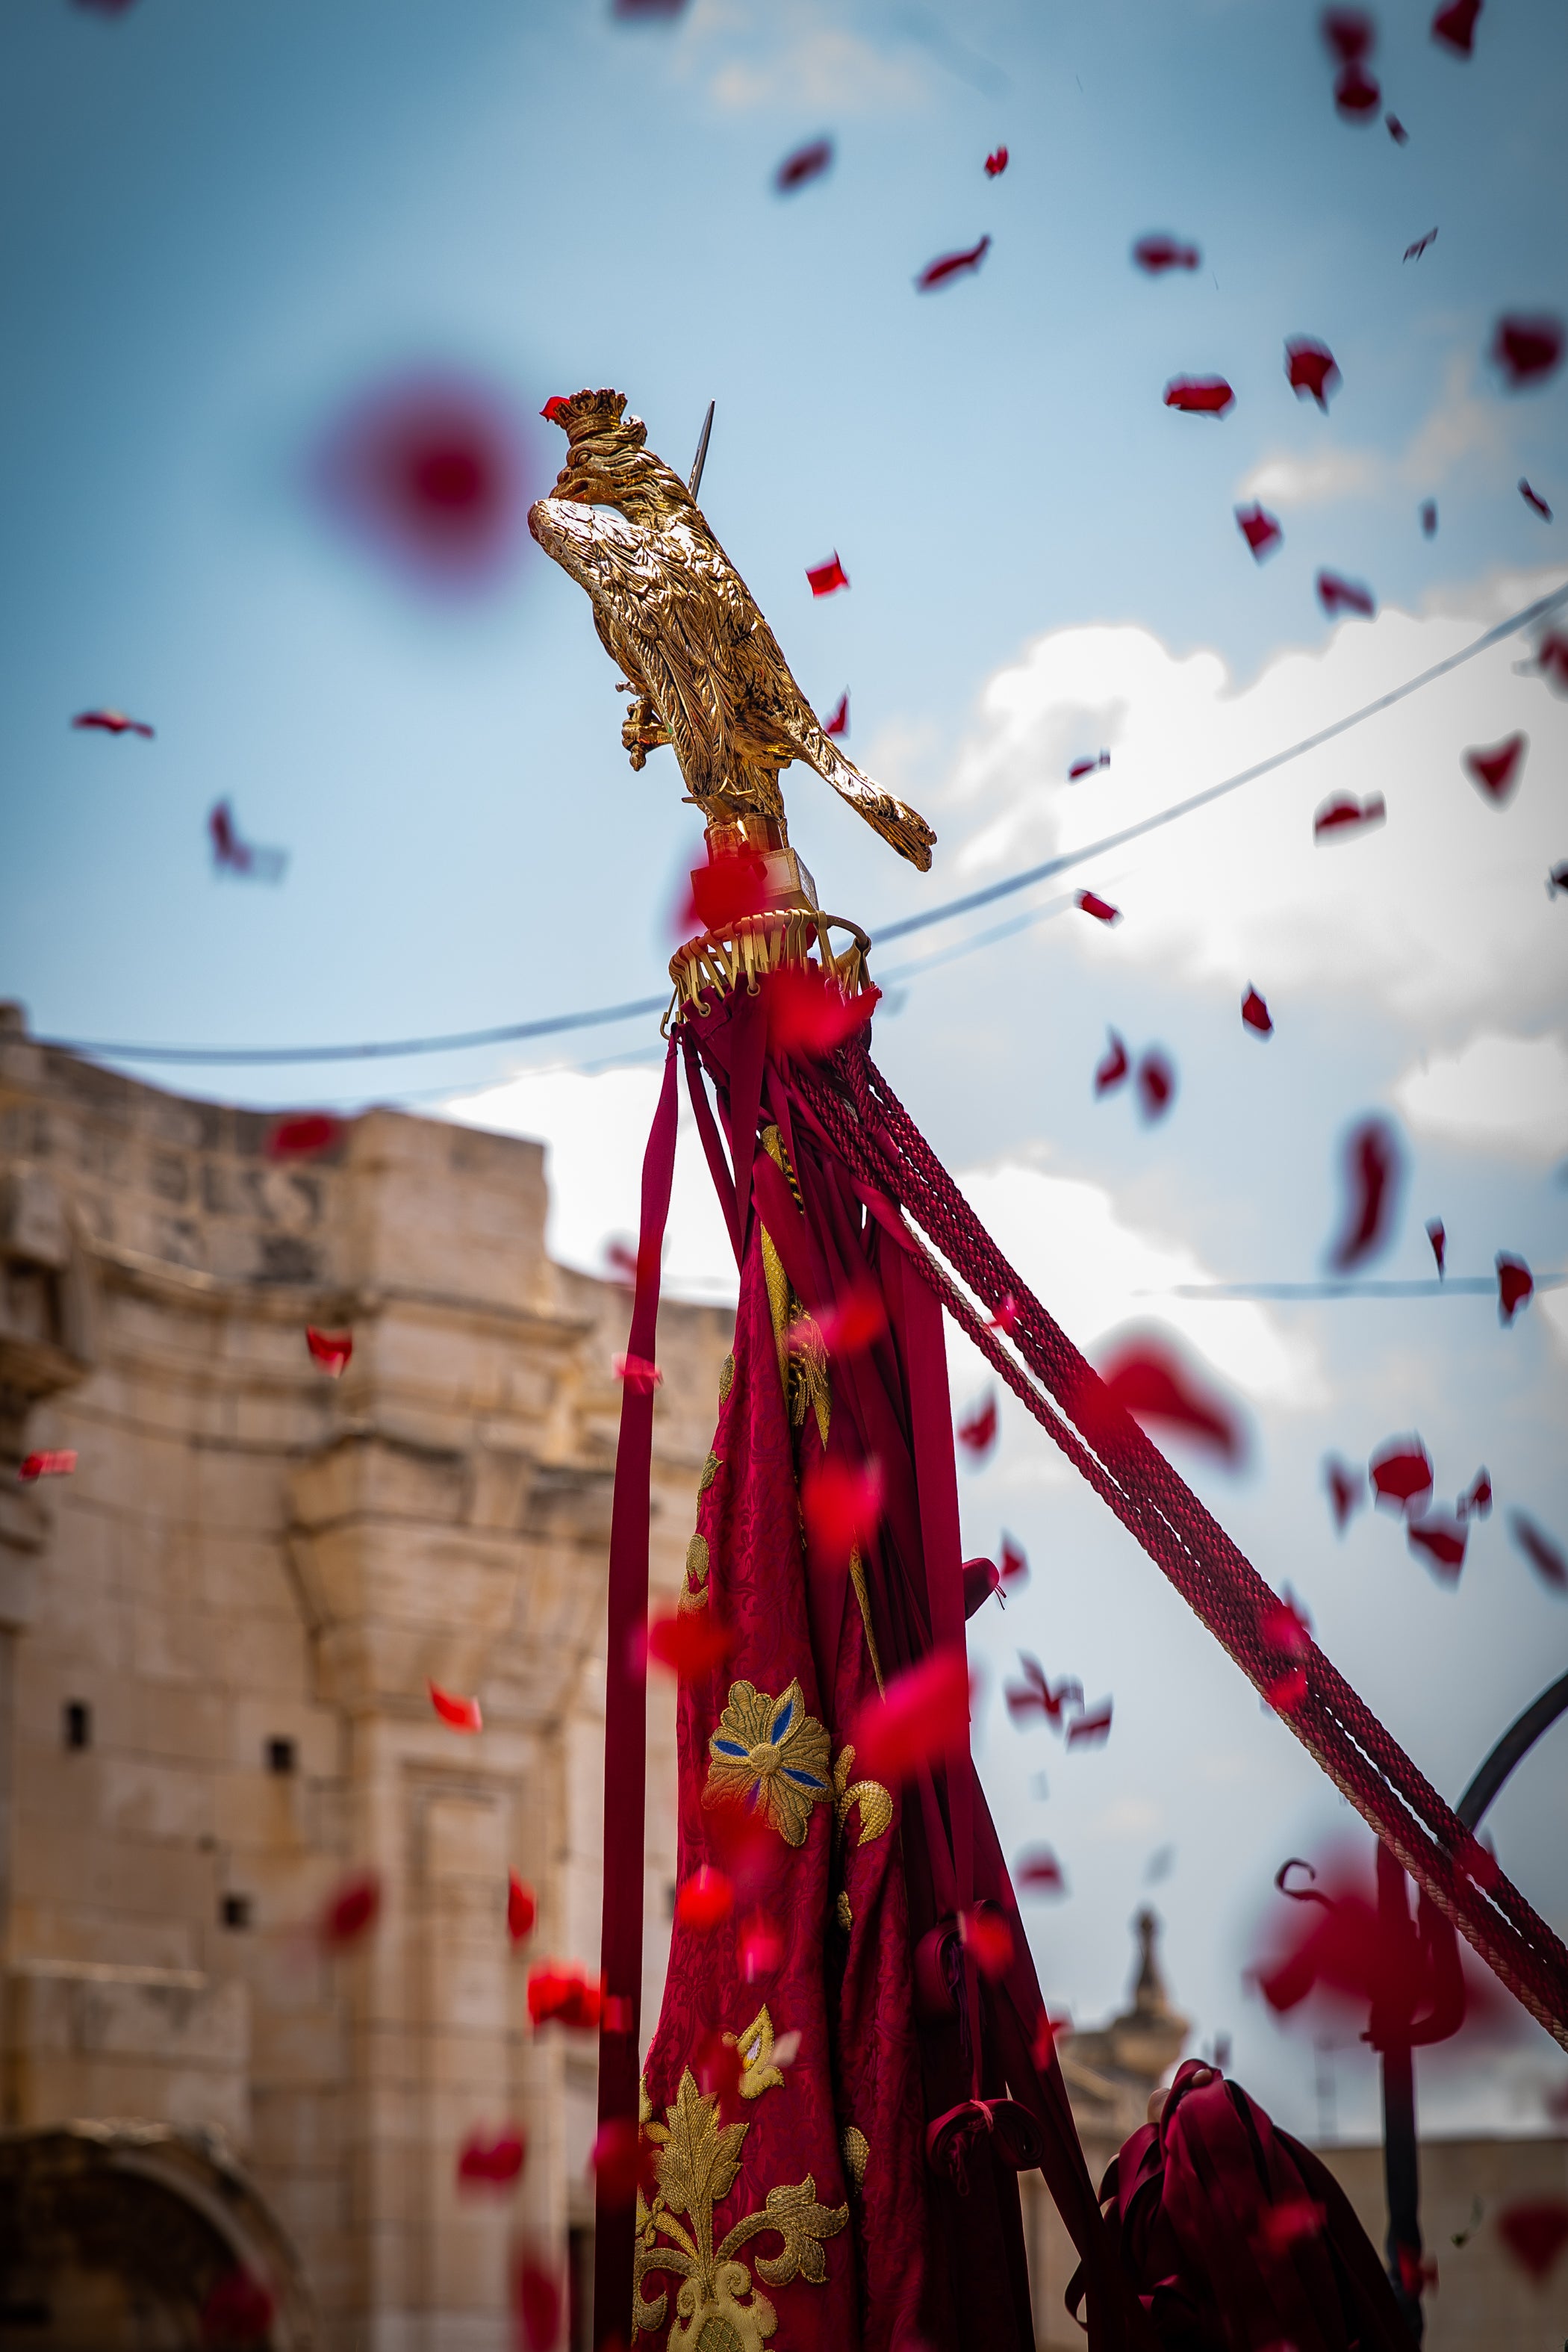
[317,376,522,585]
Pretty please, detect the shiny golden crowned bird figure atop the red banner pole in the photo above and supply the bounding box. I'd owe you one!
[529,391,936,873]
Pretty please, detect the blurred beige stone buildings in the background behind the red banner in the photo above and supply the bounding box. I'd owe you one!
[0,1007,1568,2352]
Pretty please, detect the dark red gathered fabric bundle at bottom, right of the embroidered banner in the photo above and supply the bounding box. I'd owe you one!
[1067,2058,1410,2352]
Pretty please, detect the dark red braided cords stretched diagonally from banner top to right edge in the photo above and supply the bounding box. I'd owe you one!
[802,1042,1568,2049]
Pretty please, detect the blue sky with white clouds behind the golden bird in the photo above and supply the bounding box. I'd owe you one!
[0,0,1568,2129]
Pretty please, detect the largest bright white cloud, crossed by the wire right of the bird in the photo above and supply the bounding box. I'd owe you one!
[945,576,1568,1025]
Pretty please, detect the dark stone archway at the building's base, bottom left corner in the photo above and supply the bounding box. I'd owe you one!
[0,2121,320,2352]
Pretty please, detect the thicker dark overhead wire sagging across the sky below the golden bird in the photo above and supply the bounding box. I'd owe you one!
[52,583,1568,1065]
